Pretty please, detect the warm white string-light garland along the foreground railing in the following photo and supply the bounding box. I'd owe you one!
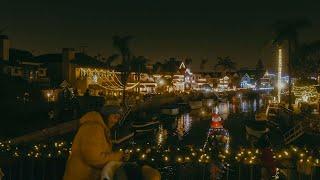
[0,141,320,167]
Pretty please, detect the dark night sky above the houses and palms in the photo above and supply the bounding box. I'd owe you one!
[0,0,320,70]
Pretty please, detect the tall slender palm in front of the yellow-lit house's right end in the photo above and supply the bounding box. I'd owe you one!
[112,36,133,105]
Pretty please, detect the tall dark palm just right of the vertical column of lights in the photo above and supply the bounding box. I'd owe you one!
[272,19,311,109]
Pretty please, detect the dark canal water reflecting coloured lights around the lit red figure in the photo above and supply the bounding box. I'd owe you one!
[133,99,263,148]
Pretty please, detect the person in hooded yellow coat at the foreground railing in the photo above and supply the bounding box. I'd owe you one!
[63,106,123,180]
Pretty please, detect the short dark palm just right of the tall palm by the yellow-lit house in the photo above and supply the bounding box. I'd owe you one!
[131,56,148,95]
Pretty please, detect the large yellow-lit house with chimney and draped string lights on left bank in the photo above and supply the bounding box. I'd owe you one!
[36,48,113,94]
